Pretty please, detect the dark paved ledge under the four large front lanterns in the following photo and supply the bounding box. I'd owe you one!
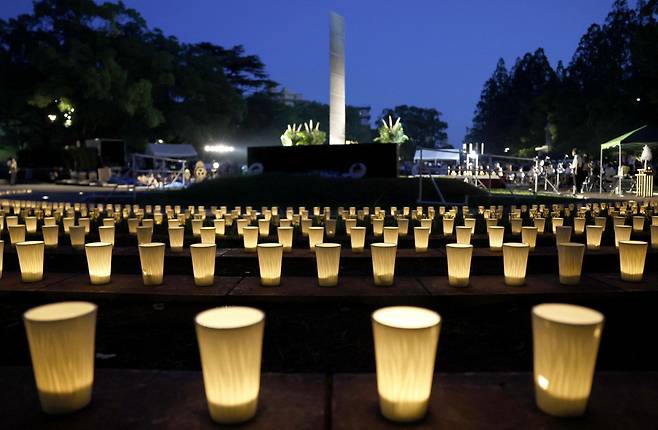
[0,367,658,430]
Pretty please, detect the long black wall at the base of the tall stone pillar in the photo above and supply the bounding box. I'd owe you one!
[247,143,398,178]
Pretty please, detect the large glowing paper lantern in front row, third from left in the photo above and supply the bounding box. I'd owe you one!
[372,306,441,422]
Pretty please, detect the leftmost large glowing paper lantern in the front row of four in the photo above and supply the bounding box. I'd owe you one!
[23,302,96,414]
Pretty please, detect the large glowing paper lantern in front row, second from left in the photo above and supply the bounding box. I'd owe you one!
[195,306,265,424]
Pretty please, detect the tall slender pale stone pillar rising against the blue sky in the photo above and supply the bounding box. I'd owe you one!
[329,12,345,145]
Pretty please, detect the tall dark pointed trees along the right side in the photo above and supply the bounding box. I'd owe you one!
[467,0,658,155]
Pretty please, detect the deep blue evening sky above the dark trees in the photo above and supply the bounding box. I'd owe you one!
[0,0,620,145]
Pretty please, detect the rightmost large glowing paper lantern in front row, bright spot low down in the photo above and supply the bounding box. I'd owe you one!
[532,303,604,417]
